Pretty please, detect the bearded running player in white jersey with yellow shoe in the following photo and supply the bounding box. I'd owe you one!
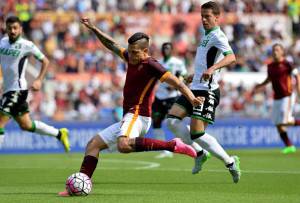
[0,16,70,152]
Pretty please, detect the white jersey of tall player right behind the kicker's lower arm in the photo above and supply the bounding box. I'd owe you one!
[191,27,233,90]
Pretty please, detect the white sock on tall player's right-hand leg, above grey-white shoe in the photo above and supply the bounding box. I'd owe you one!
[194,133,234,165]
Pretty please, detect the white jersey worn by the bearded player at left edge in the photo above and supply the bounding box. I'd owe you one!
[0,37,45,93]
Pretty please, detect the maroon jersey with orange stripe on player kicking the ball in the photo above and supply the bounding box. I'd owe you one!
[123,51,171,117]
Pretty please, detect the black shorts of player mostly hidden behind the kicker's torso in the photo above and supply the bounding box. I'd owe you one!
[152,97,179,118]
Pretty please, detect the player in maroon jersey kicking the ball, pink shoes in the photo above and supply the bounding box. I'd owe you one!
[59,18,203,196]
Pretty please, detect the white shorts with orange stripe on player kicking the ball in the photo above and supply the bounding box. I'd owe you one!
[98,113,151,151]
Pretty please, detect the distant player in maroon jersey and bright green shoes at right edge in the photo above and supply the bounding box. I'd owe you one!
[253,44,300,154]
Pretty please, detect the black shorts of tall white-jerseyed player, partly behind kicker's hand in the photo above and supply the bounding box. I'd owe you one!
[176,89,220,124]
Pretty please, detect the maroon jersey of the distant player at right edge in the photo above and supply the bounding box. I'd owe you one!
[268,60,293,99]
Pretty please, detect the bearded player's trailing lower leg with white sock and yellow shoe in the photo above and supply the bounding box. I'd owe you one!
[14,112,70,152]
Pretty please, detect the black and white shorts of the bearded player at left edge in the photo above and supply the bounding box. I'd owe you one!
[0,90,29,117]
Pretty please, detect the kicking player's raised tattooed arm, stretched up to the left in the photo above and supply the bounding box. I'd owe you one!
[81,18,125,59]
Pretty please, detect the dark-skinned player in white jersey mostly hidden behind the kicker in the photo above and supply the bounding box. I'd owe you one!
[152,42,206,158]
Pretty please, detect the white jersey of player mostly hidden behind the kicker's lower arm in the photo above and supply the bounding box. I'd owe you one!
[155,56,187,100]
